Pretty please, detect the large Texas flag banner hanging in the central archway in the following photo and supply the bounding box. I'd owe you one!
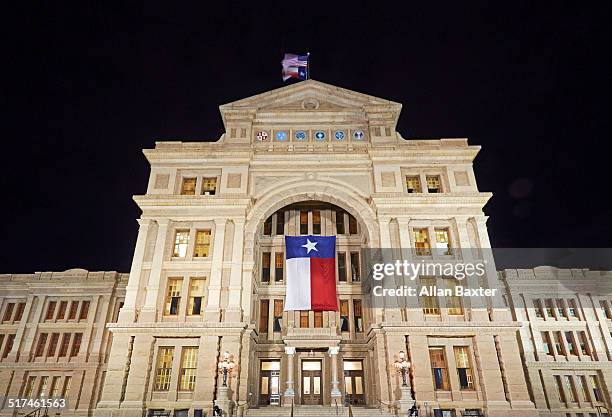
[285,235,338,311]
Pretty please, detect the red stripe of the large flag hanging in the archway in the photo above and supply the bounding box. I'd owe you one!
[310,258,338,311]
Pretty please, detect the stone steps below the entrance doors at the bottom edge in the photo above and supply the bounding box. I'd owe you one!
[244,405,395,417]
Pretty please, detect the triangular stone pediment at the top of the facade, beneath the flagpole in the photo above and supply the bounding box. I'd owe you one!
[219,80,401,121]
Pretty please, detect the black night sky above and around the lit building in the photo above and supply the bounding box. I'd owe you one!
[0,1,612,273]
